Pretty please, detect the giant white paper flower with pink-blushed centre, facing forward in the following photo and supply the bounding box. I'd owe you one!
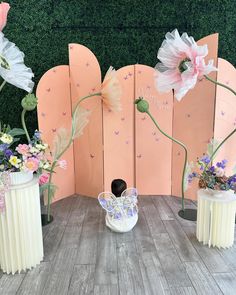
[156,29,217,101]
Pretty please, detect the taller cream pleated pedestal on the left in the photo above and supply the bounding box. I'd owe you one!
[0,172,43,274]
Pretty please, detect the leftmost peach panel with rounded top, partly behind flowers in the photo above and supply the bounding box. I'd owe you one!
[36,65,75,201]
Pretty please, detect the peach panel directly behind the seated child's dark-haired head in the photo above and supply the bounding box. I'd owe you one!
[103,66,135,191]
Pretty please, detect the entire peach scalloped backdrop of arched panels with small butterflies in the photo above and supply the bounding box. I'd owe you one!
[37,34,230,199]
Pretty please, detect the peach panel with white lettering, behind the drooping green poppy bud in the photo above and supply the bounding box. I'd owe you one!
[135,65,173,195]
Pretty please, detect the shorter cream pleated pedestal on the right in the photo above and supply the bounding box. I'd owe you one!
[197,189,236,248]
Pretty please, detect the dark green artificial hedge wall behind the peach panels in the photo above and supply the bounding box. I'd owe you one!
[0,0,236,132]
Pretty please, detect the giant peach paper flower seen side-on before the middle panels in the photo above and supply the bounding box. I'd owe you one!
[101,67,121,111]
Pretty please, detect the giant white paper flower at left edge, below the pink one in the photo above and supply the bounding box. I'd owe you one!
[0,32,34,92]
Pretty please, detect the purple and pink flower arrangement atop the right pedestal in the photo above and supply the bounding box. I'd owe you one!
[188,155,236,193]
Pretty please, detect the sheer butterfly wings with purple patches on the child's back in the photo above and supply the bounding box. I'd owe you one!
[98,188,138,219]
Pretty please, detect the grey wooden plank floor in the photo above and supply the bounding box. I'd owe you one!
[0,196,236,295]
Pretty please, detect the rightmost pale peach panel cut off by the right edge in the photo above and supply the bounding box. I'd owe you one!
[214,58,236,175]
